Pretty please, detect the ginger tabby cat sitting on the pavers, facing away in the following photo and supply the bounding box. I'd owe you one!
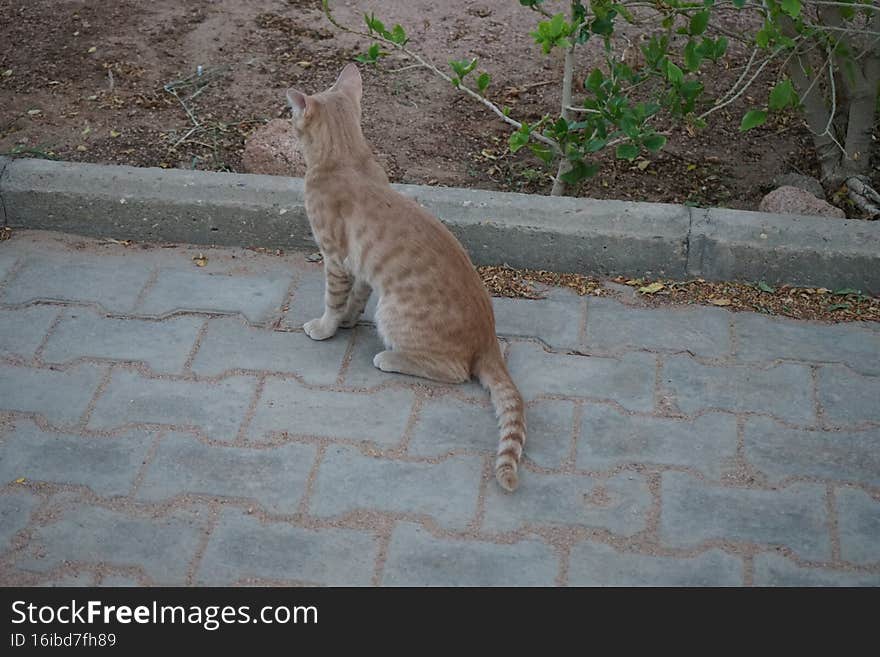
[287,64,526,491]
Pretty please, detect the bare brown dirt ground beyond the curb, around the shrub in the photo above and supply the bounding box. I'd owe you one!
[0,0,860,209]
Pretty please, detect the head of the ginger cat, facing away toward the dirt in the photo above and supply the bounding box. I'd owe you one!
[287,64,363,146]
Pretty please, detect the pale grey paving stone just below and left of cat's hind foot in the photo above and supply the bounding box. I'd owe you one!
[248,379,414,445]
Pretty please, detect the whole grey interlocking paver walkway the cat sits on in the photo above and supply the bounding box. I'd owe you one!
[0,231,880,586]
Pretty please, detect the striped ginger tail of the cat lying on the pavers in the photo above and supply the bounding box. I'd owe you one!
[475,340,526,491]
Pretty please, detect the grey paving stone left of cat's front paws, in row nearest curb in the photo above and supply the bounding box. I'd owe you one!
[137,269,293,323]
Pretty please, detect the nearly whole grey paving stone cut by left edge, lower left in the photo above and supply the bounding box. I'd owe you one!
[0,420,153,496]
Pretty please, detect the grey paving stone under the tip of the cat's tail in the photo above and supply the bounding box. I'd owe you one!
[483,471,651,536]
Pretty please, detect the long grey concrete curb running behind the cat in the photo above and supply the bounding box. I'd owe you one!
[0,158,880,293]
